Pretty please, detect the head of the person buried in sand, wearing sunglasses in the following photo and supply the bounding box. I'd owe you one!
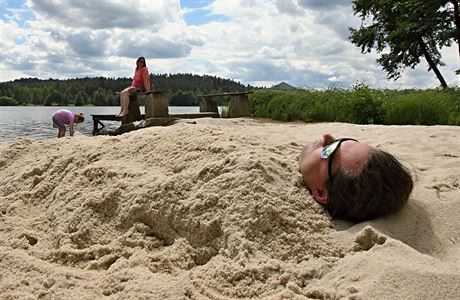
[299,134,413,221]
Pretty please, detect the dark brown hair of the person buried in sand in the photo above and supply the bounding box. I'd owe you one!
[326,149,414,221]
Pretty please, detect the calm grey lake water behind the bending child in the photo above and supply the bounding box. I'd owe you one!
[0,106,200,146]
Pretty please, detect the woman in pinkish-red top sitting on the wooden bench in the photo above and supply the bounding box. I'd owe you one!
[117,56,150,117]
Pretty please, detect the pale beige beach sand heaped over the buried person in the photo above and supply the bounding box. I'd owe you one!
[0,118,460,299]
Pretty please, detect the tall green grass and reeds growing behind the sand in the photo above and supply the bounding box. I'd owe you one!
[249,83,460,125]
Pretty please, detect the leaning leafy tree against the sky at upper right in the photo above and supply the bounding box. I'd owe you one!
[349,0,458,88]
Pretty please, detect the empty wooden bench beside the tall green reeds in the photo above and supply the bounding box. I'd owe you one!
[200,91,252,118]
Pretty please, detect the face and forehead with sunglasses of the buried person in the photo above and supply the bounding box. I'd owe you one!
[299,134,370,204]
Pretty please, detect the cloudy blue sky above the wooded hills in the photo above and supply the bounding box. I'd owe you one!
[0,0,460,89]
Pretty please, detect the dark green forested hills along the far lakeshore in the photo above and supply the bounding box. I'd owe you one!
[0,74,253,106]
